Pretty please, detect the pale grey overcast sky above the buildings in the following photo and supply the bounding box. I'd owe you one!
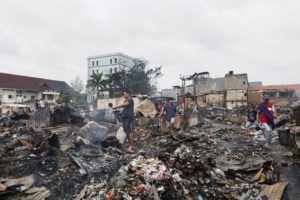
[0,0,300,88]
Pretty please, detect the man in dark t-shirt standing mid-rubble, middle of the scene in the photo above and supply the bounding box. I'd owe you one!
[161,98,177,131]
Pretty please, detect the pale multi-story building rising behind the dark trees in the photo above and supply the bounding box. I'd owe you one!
[88,53,137,79]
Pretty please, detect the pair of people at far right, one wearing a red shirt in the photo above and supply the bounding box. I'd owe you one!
[246,95,277,148]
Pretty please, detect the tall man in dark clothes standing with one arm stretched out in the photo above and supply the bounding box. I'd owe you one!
[114,90,134,153]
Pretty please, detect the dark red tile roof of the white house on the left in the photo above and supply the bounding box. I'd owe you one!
[0,73,73,93]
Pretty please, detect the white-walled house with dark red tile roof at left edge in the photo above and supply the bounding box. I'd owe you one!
[0,73,74,104]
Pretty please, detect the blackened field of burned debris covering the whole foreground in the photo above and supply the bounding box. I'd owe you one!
[0,101,300,200]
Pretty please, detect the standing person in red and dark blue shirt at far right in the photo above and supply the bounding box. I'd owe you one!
[257,95,277,148]
